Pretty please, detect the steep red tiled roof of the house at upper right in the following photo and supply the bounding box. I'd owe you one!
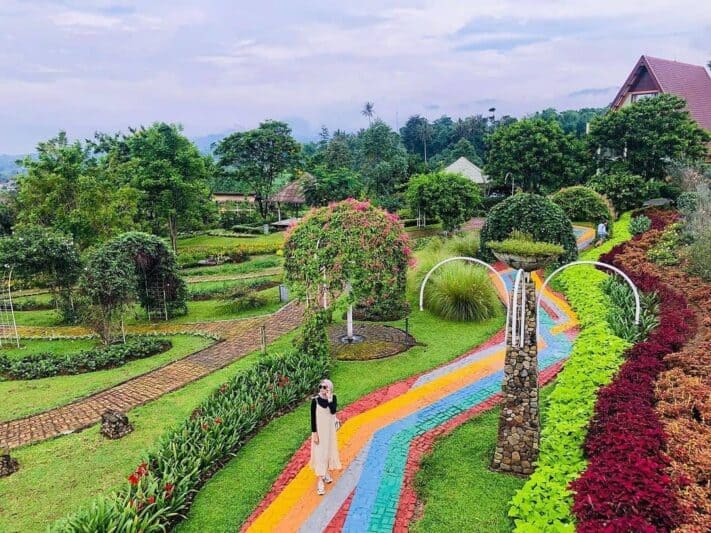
[612,55,711,131]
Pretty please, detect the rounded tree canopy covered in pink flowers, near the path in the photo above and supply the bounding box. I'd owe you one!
[284,199,411,320]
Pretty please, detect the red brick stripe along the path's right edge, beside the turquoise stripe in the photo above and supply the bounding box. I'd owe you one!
[393,361,564,533]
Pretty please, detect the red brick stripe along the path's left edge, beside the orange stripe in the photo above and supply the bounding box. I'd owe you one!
[240,330,504,531]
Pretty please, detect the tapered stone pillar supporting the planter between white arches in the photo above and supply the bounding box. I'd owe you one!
[491,273,541,475]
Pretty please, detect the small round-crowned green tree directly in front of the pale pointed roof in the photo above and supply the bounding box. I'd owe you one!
[406,172,482,231]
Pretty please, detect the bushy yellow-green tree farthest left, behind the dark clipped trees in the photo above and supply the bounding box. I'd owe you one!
[17,132,139,248]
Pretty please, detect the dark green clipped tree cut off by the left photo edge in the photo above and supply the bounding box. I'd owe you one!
[0,226,81,322]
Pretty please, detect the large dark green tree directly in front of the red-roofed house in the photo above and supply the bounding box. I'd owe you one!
[587,94,711,179]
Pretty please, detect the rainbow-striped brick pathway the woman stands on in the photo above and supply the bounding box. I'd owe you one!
[242,228,594,533]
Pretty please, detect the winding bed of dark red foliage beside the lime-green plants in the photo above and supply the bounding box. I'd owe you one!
[571,213,694,532]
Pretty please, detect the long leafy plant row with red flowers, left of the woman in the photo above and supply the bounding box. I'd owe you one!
[52,351,328,532]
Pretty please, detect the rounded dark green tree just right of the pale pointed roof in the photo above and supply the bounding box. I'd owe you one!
[485,118,583,192]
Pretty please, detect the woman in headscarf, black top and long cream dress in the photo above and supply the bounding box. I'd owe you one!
[310,379,341,495]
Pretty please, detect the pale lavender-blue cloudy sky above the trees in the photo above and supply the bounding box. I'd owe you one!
[0,0,711,153]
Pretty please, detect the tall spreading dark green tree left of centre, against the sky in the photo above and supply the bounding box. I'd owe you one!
[215,120,300,219]
